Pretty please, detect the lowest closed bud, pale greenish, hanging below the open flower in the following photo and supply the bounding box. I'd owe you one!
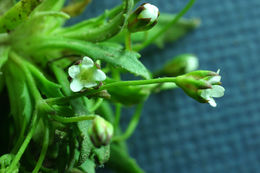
[88,116,114,148]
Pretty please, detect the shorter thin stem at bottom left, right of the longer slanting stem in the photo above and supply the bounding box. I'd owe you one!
[32,127,50,173]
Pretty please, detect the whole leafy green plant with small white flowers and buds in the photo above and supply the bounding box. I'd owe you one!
[0,0,224,173]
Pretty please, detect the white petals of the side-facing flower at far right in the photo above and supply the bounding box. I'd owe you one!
[200,70,225,107]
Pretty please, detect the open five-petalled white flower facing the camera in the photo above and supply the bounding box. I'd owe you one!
[68,56,106,92]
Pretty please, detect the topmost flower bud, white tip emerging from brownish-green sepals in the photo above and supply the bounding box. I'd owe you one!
[127,3,160,32]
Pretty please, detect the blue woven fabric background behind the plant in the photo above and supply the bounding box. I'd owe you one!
[68,0,260,173]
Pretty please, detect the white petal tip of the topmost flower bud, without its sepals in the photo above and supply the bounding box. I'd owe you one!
[137,3,159,23]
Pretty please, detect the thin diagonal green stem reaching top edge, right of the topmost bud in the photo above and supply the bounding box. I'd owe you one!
[134,0,196,52]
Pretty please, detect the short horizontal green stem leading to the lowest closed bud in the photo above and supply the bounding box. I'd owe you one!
[51,114,97,123]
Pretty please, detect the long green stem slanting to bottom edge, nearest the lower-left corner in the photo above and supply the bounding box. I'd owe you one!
[7,108,38,173]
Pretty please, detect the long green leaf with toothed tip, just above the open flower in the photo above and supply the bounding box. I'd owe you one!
[34,38,150,79]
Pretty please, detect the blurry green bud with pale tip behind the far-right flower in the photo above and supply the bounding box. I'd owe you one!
[155,54,199,77]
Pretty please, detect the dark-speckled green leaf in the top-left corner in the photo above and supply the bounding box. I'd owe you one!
[0,0,42,33]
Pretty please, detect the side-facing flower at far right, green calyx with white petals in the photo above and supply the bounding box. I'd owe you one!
[175,70,225,107]
